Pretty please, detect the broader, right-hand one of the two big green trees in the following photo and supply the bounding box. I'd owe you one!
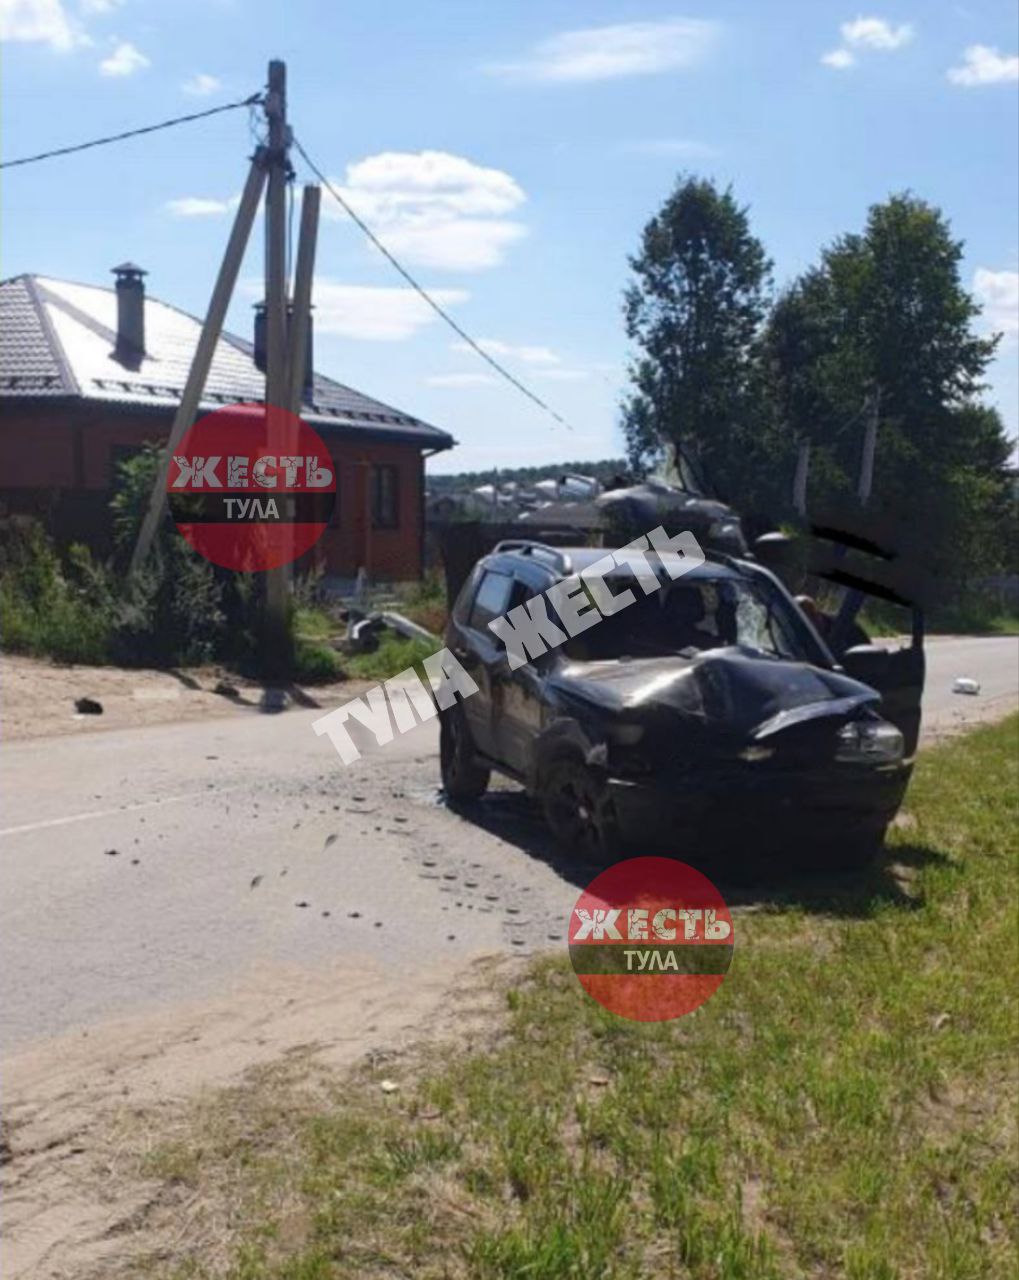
[763,193,1009,584]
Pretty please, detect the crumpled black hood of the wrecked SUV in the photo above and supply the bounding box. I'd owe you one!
[553,648,881,739]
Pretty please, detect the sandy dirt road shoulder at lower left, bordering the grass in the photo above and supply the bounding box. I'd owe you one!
[0,956,520,1280]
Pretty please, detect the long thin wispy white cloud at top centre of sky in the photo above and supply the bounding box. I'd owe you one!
[486,18,718,84]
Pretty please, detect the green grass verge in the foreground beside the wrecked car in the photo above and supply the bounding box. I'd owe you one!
[139,717,1019,1280]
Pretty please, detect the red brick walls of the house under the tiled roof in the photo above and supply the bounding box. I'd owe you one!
[0,401,424,580]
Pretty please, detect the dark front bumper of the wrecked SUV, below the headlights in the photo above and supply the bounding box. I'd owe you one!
[608,763,911,861]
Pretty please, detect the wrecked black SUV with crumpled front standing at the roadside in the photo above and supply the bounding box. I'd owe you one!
[440,541,923,868]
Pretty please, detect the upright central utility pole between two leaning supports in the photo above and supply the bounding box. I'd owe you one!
[262,60,293,710]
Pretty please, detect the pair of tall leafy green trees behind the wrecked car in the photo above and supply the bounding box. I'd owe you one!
[622,177,1015,579]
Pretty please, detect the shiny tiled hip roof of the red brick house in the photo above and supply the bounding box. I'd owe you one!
[0,275,454,449]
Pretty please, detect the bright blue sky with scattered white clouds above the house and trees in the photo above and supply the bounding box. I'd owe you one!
[0,0,1019,471]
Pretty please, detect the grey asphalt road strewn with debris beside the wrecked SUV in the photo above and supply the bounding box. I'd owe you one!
[0,637,1019,1053]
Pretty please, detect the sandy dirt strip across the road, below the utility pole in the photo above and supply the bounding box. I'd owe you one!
[0,654,370,741]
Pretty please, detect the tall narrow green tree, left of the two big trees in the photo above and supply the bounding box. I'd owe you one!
[622,177,771,497]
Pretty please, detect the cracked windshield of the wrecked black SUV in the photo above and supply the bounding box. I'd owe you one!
[565,573,817,662]
